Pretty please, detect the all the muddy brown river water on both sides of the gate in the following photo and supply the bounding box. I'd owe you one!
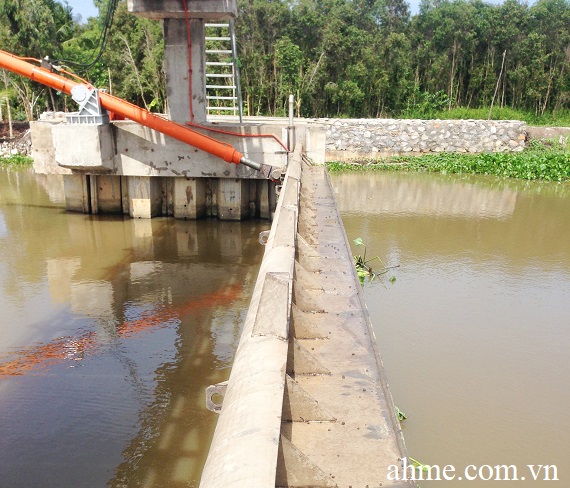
[0,169,570,488]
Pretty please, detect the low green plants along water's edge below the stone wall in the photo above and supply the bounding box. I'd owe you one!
[327,141,570,182]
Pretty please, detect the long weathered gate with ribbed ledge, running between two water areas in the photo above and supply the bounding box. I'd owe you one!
[200,154,415,488]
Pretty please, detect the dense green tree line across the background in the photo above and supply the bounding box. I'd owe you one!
[0,0,570,118]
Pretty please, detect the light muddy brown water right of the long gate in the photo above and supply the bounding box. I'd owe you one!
[332,173,570,488]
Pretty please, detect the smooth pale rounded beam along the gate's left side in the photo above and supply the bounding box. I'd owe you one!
[200,154,300,488]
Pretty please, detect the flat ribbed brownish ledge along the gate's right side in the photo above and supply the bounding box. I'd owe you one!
[278,159,414,488]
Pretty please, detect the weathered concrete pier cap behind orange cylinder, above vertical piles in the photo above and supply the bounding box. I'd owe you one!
[31,121,287,179]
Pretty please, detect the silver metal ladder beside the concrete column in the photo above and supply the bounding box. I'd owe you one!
[205,20,243,123]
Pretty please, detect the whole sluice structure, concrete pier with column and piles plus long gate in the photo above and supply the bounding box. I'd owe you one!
[15,0,414,480]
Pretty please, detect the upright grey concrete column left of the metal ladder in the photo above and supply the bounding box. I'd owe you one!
[163,18,206,124]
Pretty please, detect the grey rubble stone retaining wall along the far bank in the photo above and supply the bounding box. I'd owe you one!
[315,119,526,161]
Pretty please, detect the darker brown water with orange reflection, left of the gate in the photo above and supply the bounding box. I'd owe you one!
[0,168,269,488]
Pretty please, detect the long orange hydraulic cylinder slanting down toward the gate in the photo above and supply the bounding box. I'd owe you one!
[0,50,266,172]
